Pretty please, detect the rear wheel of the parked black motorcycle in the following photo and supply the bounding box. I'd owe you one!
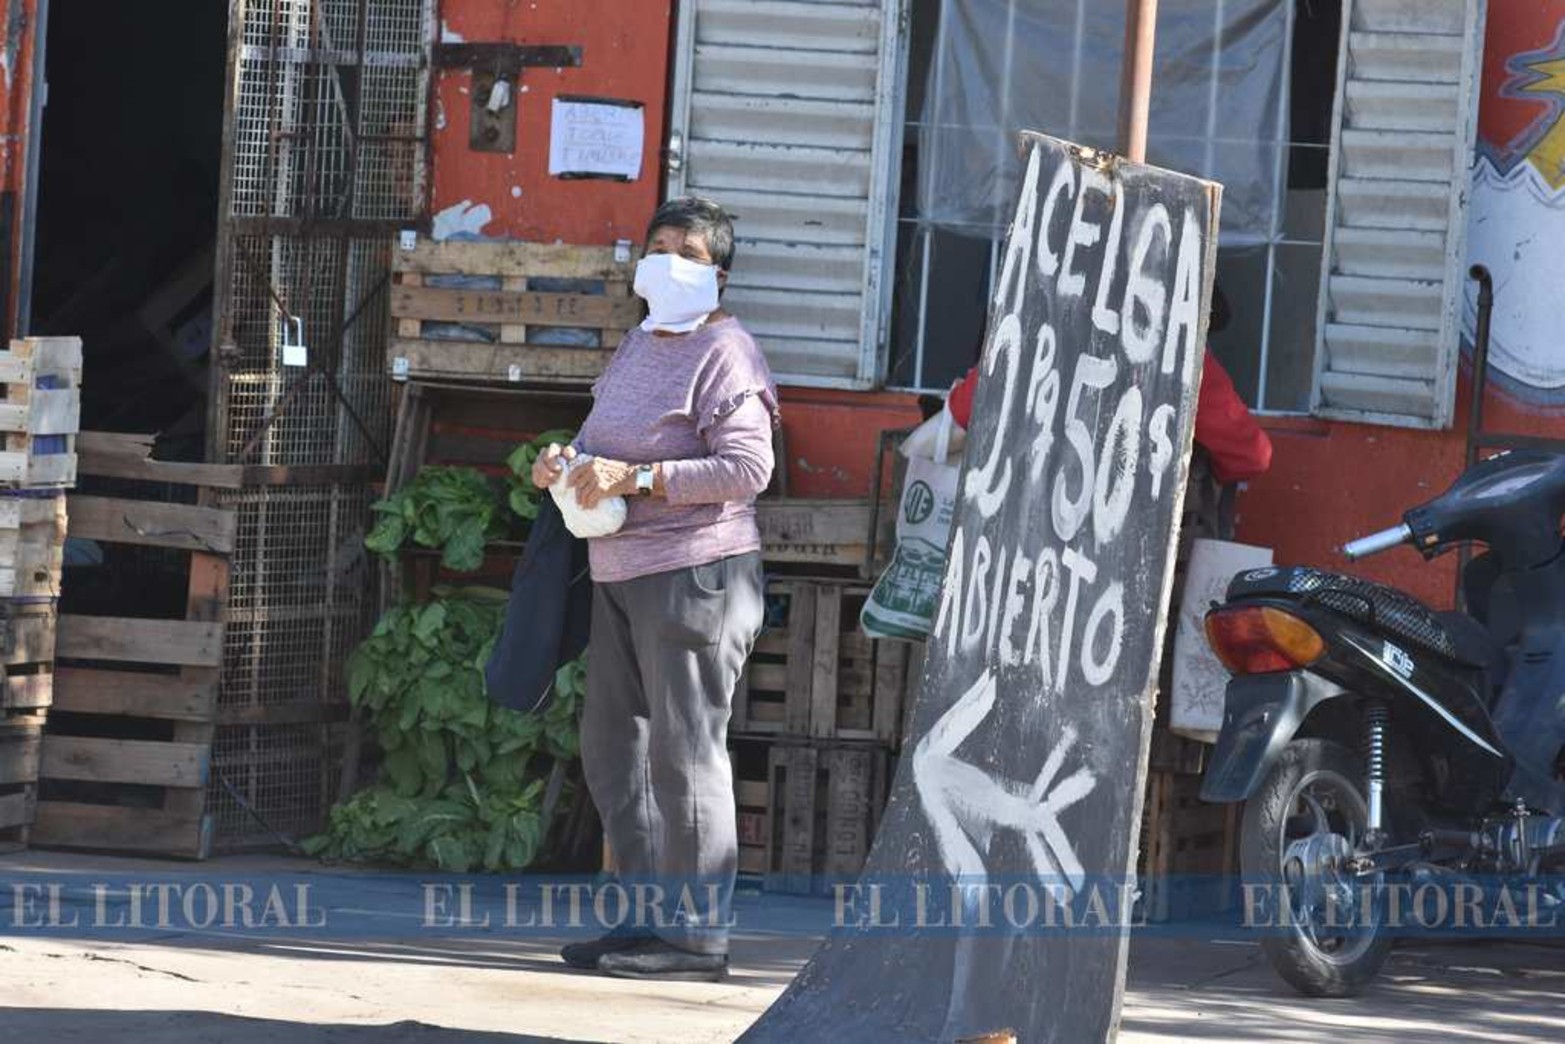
[1239,739,1391,997]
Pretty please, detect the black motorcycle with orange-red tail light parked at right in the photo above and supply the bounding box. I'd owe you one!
[1202,449,1565,997]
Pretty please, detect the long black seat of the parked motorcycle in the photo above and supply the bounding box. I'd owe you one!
[1229,565,1491,667]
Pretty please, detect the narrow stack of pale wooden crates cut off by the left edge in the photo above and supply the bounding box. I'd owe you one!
[0,337,81,847]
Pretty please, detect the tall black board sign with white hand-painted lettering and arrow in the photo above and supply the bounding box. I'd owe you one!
[745,135,1221,1044]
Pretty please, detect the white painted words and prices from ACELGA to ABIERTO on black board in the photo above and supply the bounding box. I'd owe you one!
[934,149,1205,692]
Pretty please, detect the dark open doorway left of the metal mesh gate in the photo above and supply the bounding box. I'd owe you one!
[30,0,228,460]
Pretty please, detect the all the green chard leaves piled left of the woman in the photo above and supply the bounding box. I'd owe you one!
[304,430,587,872]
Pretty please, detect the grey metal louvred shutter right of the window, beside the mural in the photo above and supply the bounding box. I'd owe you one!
[1315,0,1485,427]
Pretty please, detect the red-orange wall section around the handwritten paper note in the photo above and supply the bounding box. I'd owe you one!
[430,0,673,246]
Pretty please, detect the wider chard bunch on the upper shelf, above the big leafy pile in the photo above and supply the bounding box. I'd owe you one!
[365,466,509,573]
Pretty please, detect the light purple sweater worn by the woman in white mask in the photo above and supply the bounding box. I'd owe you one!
[576,316,779,584]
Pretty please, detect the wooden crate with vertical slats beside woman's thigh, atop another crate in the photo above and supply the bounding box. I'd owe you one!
[729,579,909,747]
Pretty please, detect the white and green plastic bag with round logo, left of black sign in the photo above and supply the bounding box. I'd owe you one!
[859,409,961,640]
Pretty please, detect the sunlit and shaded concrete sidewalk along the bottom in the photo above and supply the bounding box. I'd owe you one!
[0,853,1565,1044]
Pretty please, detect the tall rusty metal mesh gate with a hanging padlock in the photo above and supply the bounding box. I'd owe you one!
[210,0,435,848]
